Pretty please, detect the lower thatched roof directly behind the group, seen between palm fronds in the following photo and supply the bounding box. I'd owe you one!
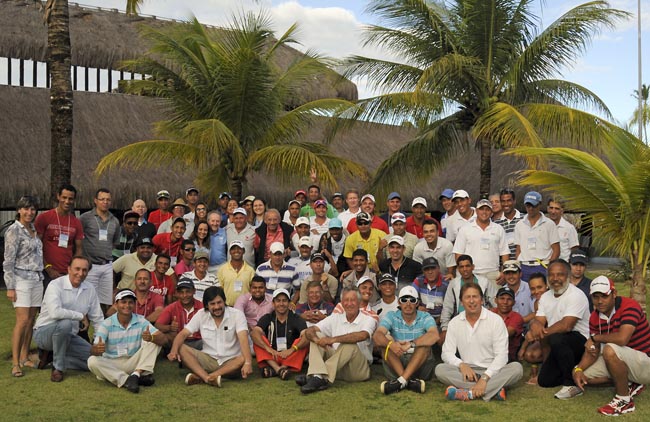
[0,86,523,209]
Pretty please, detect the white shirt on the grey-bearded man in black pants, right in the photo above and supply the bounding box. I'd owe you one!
[536,282,589,338]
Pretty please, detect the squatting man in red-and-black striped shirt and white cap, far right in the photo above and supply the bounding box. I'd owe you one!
[573,275,650,416]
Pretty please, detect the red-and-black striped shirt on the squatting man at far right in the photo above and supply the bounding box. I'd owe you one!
[589,296,650,356]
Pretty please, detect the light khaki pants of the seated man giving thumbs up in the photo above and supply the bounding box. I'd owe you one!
[88,341,160,387]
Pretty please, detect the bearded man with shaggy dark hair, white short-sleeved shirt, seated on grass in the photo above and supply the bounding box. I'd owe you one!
[167,286,253,387]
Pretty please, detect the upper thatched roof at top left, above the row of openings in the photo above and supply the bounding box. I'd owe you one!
[0,0,357,103]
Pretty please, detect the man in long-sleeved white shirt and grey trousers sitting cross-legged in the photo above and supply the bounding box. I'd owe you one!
[436,282,523,401]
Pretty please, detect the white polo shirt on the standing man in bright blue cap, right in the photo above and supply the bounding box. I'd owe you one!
[515,213,560,262]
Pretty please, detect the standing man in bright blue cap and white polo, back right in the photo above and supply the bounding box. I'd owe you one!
[515,191,560,282]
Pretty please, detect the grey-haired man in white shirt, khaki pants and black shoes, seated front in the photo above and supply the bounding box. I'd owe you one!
[296,287,377,394]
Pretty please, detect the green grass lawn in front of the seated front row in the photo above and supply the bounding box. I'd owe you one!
[0,300,650,422]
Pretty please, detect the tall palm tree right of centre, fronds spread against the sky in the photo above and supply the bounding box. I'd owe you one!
[335,0,628,197]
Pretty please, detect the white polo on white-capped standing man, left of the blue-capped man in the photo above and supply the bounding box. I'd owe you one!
[454,220,510,275]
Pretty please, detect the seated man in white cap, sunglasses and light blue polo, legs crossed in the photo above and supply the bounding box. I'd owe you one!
[372,286,439,394]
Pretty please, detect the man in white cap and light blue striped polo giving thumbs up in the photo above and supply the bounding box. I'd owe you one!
[88,289,166,393]
